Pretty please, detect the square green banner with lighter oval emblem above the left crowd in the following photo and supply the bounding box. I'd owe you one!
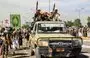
[10,14,21,28]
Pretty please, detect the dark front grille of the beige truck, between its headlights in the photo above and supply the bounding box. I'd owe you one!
[49,40,72,49]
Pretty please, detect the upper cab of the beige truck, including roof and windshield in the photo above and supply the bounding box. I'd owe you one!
[32,21,66,33]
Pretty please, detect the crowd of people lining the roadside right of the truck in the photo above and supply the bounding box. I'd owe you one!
[67,27,90,37]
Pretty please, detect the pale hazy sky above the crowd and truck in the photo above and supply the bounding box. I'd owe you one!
[0,0,90,24]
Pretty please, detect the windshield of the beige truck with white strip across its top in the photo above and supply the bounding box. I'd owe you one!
[38,23,64,33]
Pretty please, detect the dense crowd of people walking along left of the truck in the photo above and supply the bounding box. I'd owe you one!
[0,28,30,55]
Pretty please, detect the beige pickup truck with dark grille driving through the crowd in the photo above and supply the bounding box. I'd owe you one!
[30,21,82,58]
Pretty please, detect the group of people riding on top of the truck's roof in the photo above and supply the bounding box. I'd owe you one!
[33,9,60,21]
